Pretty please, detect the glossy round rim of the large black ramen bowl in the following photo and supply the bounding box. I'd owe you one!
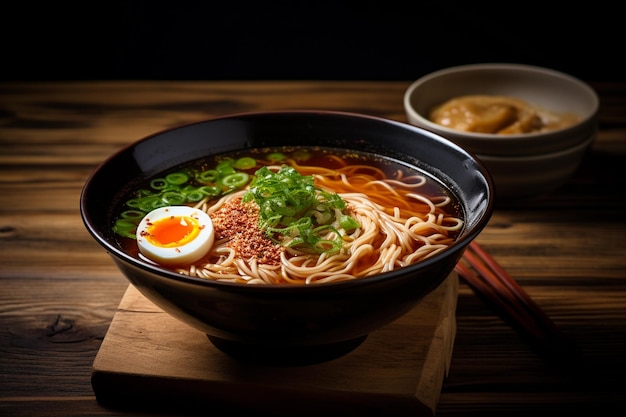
[79,109,496,293]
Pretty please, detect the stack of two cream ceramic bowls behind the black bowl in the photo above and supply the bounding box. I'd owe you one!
[404,63,600,202]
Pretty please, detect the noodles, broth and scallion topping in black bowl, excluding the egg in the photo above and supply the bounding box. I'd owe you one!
[112,148,464,285]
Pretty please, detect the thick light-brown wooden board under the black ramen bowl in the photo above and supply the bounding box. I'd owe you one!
[91,273,458,416]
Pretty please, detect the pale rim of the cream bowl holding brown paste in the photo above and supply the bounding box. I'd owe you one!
[403,62,600,142]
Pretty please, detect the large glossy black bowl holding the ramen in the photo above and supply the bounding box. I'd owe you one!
[80,111,494,364]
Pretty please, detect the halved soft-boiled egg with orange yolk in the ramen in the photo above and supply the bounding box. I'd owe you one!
[137,206,215,265]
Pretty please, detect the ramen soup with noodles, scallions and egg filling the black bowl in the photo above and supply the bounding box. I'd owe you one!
[112,147,463,285]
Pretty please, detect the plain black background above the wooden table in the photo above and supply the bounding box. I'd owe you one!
[0,0,626,81]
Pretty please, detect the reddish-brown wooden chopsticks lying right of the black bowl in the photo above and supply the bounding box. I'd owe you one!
[455,241,578,359]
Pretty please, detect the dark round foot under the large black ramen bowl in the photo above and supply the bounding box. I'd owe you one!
[207,335,367,366]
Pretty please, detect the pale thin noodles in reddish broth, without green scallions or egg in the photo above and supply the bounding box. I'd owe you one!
[177,161,463,285]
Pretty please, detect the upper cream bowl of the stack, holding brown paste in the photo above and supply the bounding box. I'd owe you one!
[404,63,599,156]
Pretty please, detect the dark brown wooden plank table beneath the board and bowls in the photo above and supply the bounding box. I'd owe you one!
[0,81,626,417]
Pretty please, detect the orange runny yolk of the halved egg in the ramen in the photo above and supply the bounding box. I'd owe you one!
[144,216,201,248]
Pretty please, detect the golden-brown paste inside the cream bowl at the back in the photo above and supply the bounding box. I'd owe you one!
[429,95,579,135]
